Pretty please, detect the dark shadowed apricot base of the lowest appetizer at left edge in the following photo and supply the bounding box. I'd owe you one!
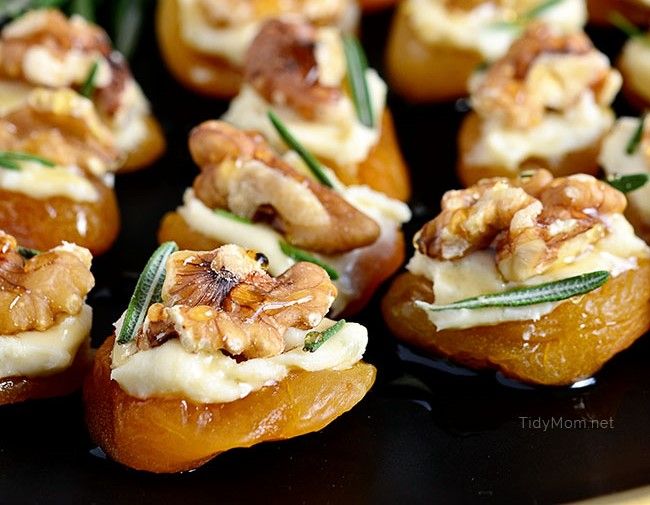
[0,342,92,405]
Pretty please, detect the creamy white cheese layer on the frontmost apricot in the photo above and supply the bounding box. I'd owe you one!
[111,319,368,403]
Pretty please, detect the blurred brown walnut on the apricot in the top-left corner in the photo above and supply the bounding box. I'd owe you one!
[0,9,132,118]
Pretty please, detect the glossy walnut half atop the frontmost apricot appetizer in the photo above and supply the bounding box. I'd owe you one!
[137,245,336,358]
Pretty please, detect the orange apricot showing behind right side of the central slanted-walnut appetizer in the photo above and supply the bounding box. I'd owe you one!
[322,109,411,202]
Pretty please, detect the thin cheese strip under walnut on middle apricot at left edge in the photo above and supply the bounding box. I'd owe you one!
[0,161,99,202]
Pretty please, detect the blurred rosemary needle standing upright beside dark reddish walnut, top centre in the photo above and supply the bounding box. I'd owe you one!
[343,35,375,128]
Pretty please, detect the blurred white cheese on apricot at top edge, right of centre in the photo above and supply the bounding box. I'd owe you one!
[404,0,587,61]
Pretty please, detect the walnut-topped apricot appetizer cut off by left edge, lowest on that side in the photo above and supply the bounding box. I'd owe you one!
[0,230,95,404]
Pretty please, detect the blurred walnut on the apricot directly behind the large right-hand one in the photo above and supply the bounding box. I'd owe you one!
[470,23,620,128]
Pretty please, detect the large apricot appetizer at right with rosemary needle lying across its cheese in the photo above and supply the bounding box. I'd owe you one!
[382,169,650,385]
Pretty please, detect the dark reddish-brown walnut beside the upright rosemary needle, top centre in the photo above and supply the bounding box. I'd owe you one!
[244,19,342,119]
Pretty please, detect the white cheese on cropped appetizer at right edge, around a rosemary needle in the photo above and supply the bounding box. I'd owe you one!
[598,117,650,225]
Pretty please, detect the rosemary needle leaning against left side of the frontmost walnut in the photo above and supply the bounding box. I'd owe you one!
[117,242,178,344]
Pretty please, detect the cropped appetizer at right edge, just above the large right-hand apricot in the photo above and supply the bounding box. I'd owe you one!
[599,117,650,243]
